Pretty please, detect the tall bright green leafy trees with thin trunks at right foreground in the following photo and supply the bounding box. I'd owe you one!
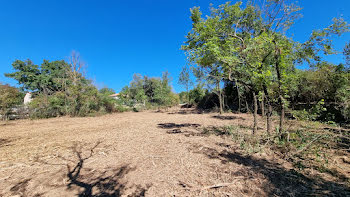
[183,0,348,135]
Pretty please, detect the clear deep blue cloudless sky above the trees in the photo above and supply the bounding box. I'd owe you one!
[0,0,350,92]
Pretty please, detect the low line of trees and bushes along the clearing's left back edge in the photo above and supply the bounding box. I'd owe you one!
[0,52,178,119]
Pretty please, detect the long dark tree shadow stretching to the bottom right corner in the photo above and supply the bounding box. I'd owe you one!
[195,145,350,196]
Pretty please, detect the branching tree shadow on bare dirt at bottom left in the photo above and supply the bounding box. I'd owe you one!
[14,142,151,197]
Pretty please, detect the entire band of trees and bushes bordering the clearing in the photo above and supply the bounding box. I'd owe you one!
[3,0,350,127]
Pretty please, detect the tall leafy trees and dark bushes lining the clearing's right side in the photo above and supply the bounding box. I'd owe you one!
[179,0,350,135]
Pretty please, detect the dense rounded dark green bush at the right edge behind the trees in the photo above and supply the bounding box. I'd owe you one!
[288,63,350,122]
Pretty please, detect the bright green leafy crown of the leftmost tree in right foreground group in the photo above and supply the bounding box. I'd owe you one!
[183,2,278,133]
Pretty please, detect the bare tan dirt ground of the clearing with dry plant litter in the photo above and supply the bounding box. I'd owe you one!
[0,110,350,196]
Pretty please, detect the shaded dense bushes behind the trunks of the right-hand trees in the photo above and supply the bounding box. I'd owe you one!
[185,62,350,123]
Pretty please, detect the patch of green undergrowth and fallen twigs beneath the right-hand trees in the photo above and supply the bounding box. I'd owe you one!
[203,121,350,183]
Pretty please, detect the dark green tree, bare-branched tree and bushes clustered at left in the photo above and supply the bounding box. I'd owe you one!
[5,53,117,118]
